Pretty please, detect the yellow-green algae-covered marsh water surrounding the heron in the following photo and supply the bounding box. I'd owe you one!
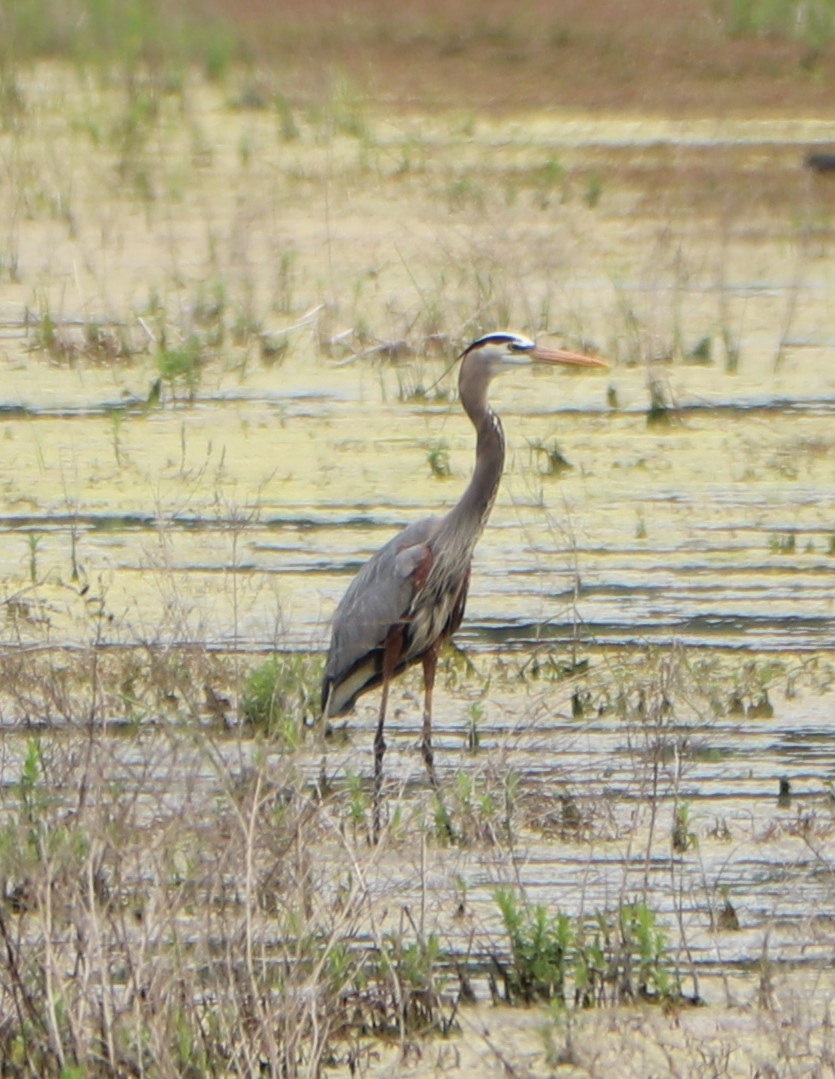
[0,68,835,1075]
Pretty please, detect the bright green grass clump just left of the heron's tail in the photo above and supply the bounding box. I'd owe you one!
[241,652,321,748]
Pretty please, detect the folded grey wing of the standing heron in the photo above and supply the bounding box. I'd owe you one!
[323,518,438,715]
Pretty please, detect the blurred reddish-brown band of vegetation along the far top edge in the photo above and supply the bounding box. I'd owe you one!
[216,0,835,115]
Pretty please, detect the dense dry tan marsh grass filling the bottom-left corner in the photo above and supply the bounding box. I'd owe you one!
[0,643,470,1076]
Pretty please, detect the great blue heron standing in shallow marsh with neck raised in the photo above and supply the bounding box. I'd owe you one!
[321,332,606,833]
